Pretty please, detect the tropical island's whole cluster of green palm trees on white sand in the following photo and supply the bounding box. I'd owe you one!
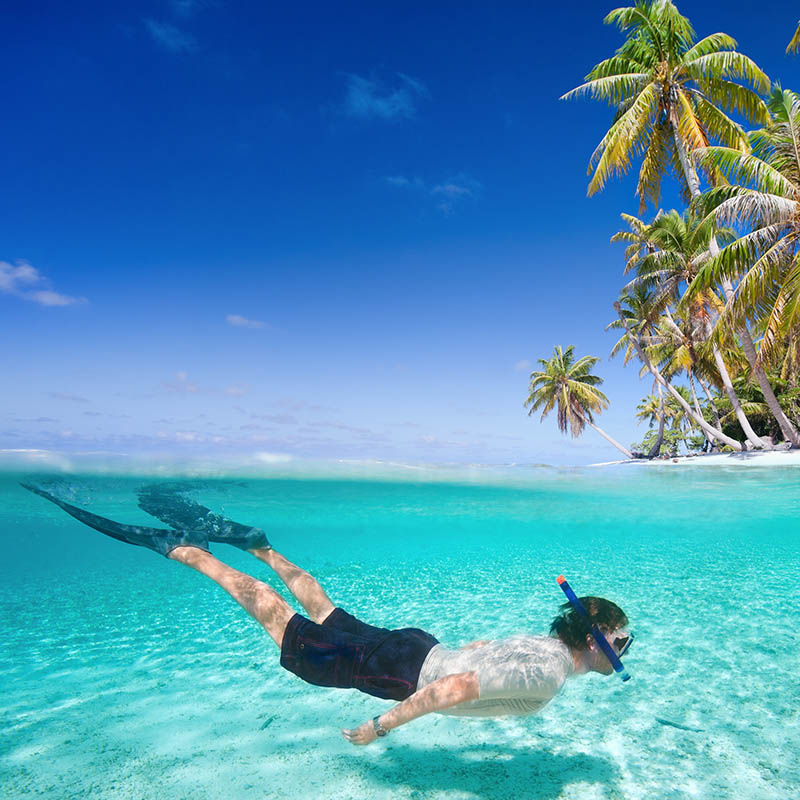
[525,0,800,459]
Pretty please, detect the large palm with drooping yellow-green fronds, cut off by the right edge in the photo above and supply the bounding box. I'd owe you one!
[693,87,800,447]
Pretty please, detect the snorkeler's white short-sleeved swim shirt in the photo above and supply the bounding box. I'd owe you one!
[417,634,574,717]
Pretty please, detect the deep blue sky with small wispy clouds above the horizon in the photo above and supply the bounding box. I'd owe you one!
[0,0,800,463]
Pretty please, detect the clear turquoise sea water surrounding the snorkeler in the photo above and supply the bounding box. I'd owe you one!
[0,467,800,800]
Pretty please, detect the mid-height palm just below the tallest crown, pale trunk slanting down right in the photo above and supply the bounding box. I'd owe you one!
[611,211,767,448]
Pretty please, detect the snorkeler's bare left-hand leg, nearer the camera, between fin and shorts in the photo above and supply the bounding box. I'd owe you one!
[168,547,296,647]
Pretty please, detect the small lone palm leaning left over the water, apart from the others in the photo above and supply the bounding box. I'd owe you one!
[524,345,633,458]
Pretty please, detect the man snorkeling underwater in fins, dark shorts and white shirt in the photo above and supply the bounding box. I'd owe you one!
[23,484,632,745]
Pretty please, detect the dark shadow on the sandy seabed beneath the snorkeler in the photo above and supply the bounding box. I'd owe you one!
[362,745,617,800]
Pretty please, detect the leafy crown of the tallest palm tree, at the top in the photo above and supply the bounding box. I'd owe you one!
[562,0,770,211]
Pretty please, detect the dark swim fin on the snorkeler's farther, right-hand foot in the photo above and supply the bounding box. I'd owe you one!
[139,483,272,550]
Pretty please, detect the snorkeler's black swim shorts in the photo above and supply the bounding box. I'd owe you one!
[281,608,439,700]
